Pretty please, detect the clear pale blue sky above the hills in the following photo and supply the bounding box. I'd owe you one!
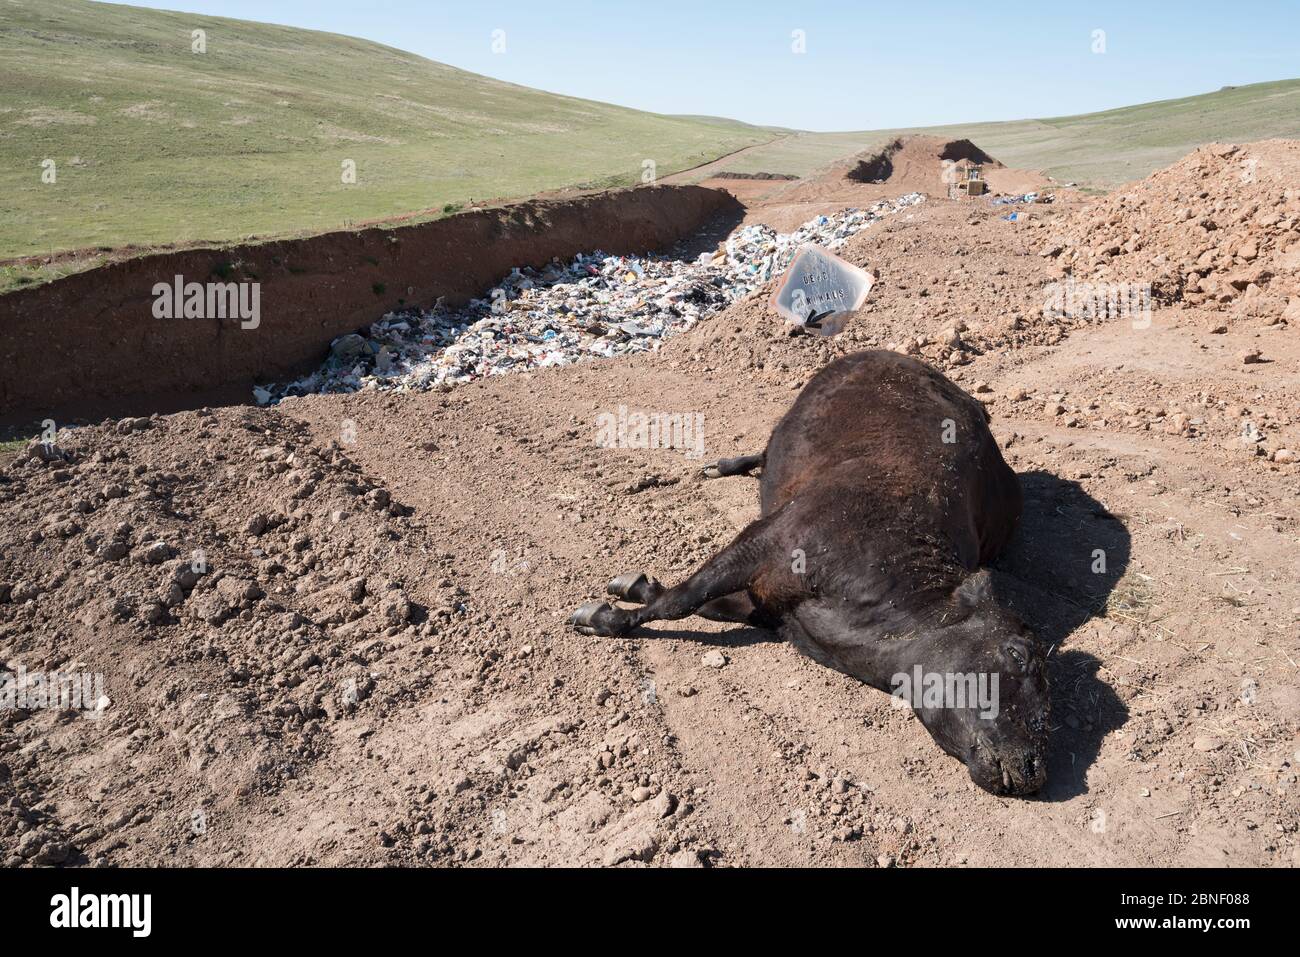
[109,0,1300,130]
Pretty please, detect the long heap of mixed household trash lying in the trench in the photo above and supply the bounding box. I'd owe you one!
[254,192,924,404]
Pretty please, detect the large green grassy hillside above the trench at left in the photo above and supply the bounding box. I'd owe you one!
[0,0,775,259]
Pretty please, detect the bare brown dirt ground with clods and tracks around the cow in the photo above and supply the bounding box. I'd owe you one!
[0,136,1300,867]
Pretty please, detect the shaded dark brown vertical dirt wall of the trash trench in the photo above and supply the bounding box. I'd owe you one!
[0,186,741,423]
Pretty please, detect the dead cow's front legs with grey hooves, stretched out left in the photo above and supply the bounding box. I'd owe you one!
[569,510,784,637]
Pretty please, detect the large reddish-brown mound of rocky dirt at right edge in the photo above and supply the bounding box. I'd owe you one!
[1044,140,1300,324]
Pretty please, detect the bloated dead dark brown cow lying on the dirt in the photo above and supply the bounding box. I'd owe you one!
[571,351,1048,794]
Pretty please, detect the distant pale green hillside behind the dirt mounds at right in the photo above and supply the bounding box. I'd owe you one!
[727,79,1300,189]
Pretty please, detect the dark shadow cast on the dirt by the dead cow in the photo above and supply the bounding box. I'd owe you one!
[993,471,1130,801]
